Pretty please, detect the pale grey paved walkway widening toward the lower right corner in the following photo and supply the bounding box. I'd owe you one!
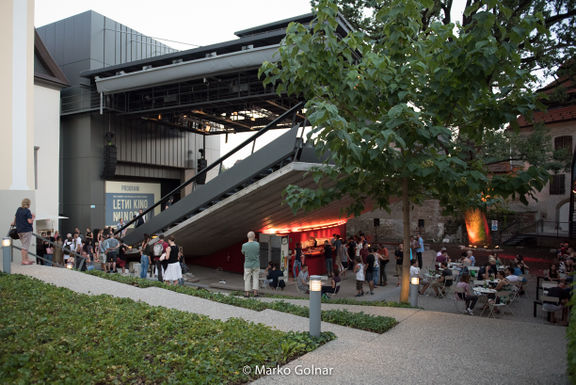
[7,258,568,385]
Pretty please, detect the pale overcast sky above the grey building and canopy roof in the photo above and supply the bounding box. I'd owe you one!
[34,0,311,50]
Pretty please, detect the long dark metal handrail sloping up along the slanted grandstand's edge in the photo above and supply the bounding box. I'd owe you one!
[114,102,304,234]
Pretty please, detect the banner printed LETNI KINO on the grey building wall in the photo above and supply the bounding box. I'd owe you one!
[106,182,161,226]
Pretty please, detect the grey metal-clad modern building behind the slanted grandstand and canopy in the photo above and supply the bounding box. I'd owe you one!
[38,11,219,232]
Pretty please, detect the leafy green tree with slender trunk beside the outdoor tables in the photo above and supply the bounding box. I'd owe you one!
[260,0,564,302]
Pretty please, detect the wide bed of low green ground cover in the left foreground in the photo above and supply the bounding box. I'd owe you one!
[0,274,335,385]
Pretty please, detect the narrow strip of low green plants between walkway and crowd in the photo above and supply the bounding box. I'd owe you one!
[88,271,398,333]
